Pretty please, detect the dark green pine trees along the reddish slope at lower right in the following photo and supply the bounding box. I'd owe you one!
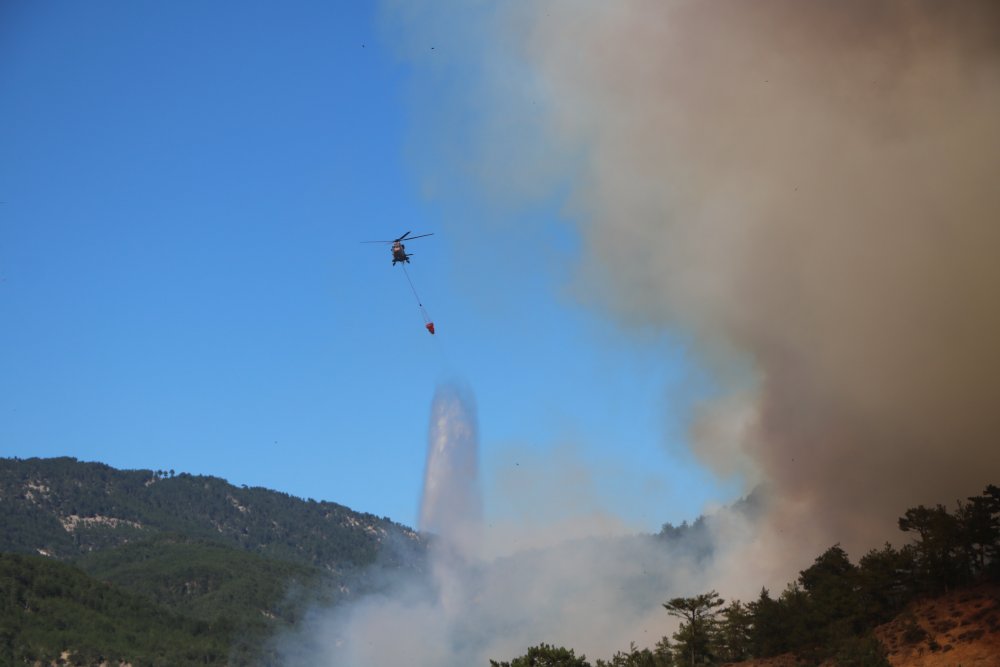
[490,484,1000,667]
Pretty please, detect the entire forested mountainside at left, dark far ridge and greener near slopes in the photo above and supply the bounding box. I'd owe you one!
[0,458,426,667]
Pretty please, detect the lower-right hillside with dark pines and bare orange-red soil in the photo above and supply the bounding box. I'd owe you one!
[491,485,1000,667]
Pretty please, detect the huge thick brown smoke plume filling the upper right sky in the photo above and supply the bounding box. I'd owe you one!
[386,0,1000,564]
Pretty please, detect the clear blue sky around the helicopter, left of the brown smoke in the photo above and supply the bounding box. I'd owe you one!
[0,2,737,530]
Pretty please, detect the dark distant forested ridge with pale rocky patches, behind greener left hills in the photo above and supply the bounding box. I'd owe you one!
[0,457,422,572]
